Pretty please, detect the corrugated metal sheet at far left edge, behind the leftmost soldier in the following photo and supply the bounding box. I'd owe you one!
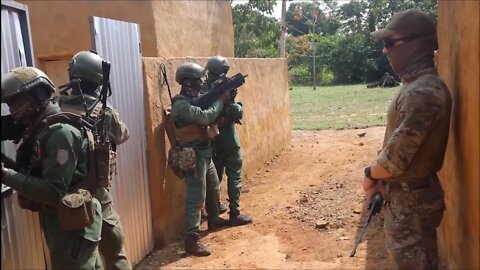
[1,2,46,269]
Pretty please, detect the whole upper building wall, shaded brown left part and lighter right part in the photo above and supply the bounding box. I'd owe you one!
[18,0,233,85]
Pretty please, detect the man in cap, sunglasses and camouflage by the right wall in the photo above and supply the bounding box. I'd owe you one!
[363,10,452,269]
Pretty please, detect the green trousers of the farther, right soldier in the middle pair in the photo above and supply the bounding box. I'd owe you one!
[213,147,243,215]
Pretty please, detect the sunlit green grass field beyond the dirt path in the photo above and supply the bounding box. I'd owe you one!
[290,84,398,130]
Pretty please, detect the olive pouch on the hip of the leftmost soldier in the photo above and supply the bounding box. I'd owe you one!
[57,189,95,231]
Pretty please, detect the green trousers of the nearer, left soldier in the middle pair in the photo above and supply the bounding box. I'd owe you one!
[185,155,219,236]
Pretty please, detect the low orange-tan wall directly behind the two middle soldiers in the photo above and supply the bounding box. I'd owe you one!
[143,58,291,245]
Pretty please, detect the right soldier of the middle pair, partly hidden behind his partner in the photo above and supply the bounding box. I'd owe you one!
[202,56,252,226]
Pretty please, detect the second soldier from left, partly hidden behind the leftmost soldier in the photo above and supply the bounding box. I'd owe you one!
[59,51,132,270]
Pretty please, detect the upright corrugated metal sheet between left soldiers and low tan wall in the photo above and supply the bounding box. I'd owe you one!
[90,17,153,264]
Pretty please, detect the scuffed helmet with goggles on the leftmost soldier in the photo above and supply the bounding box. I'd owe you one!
[2,67,55,103]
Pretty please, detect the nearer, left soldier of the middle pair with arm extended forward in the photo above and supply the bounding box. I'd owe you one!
[172,62,231,256]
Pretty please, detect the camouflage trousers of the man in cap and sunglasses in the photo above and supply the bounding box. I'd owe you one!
[383,175,445,269]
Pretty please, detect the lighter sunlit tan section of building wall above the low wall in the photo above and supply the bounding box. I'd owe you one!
[150,1,234,57]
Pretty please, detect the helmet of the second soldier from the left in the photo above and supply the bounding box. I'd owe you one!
[68,51,103,85]
